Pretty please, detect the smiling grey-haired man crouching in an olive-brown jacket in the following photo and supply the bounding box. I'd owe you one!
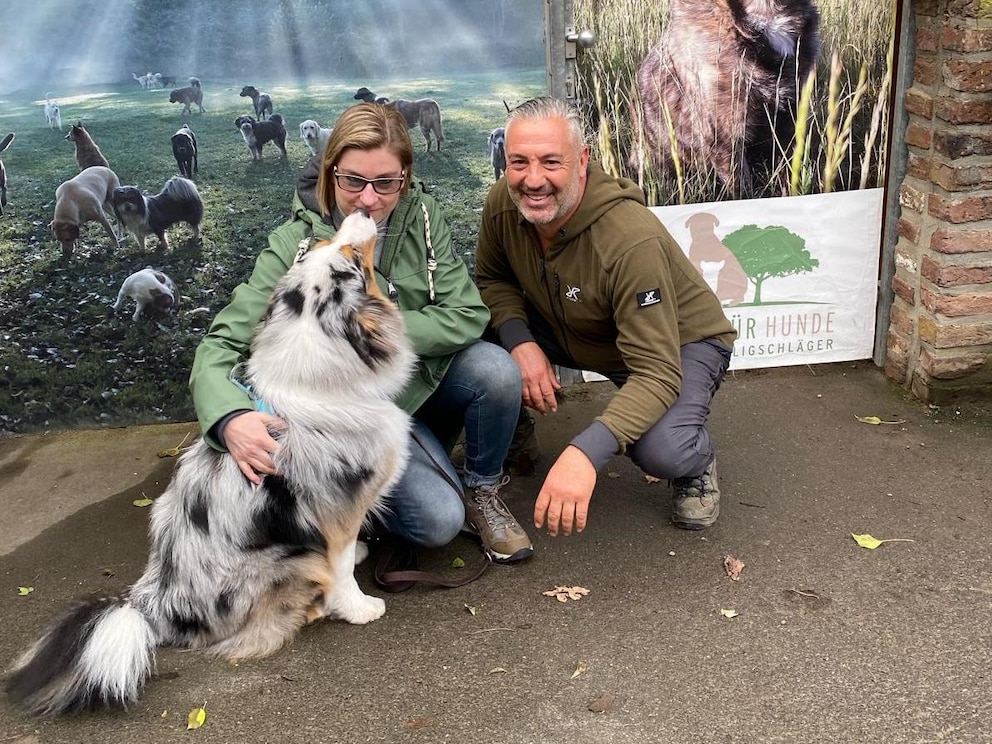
[476,98,736,536]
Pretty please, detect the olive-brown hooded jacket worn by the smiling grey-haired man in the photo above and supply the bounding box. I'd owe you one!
[475,165,736,452]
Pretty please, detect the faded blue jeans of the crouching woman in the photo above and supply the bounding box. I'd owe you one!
[376,341,522,547]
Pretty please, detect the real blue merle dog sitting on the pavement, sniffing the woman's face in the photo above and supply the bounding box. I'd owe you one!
[6,212,414,715]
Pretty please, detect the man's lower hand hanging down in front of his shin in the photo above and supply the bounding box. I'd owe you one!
[534,445,596,537]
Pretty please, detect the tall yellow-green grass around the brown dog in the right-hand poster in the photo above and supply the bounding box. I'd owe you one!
[575,0,895,204]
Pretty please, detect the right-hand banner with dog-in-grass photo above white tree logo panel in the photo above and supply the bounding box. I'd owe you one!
[564,0,895,369]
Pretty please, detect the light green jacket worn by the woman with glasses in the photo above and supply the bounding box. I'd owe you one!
[189,161,489,449]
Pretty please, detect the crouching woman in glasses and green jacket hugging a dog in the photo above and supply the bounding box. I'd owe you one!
[190,103,533,562]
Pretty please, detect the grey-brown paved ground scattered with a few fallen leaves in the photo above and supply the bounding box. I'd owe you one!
[0,363,992,744]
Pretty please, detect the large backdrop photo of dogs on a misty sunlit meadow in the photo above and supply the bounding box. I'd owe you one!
[0,0,545,434]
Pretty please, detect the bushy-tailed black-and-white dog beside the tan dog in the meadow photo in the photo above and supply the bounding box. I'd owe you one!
[110,176,203,250]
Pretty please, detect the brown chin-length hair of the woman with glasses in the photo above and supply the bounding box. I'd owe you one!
[317,103,413,217]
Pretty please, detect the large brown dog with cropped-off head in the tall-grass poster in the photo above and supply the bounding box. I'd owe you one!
[631,0,820,198]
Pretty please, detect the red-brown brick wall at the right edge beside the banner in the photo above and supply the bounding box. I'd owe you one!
[885,0,992,402]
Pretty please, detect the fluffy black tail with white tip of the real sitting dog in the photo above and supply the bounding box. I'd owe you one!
[7,599,158,715]
